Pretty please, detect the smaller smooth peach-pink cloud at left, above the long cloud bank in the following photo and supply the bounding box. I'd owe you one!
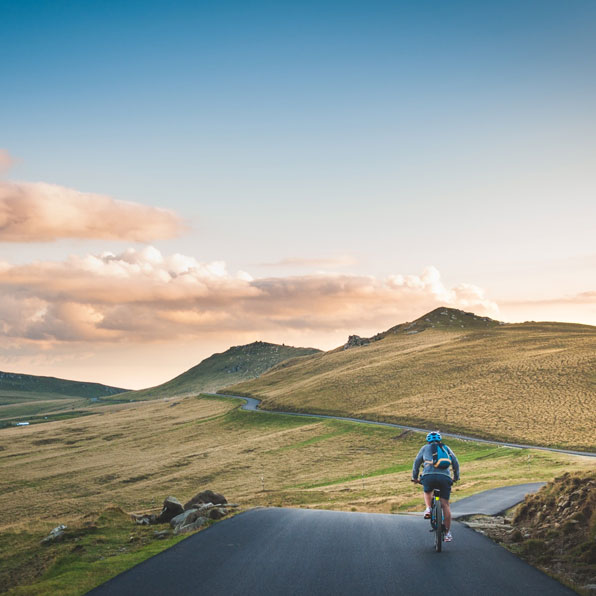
[0,180,183,242]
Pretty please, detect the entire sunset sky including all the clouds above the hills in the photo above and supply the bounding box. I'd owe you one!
[0,0,596,388]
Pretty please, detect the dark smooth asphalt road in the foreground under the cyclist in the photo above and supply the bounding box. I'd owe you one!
[89,509,575,596]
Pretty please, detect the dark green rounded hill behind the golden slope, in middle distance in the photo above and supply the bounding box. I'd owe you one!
[118,341,320,400]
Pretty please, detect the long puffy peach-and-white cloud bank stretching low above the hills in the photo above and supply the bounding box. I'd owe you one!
[0,247,498,342]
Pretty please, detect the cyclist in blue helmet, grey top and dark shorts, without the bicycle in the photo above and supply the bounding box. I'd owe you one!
[412,431,459,542]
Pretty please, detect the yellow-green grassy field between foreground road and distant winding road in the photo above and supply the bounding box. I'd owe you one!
[0,397,594,595]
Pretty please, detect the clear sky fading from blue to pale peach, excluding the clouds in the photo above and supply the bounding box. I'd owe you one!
[0,0,596,386]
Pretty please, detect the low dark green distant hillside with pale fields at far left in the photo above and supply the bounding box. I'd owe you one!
[0,372,126,426]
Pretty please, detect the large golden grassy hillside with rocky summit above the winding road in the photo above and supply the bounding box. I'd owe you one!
[222,308,596,450]
